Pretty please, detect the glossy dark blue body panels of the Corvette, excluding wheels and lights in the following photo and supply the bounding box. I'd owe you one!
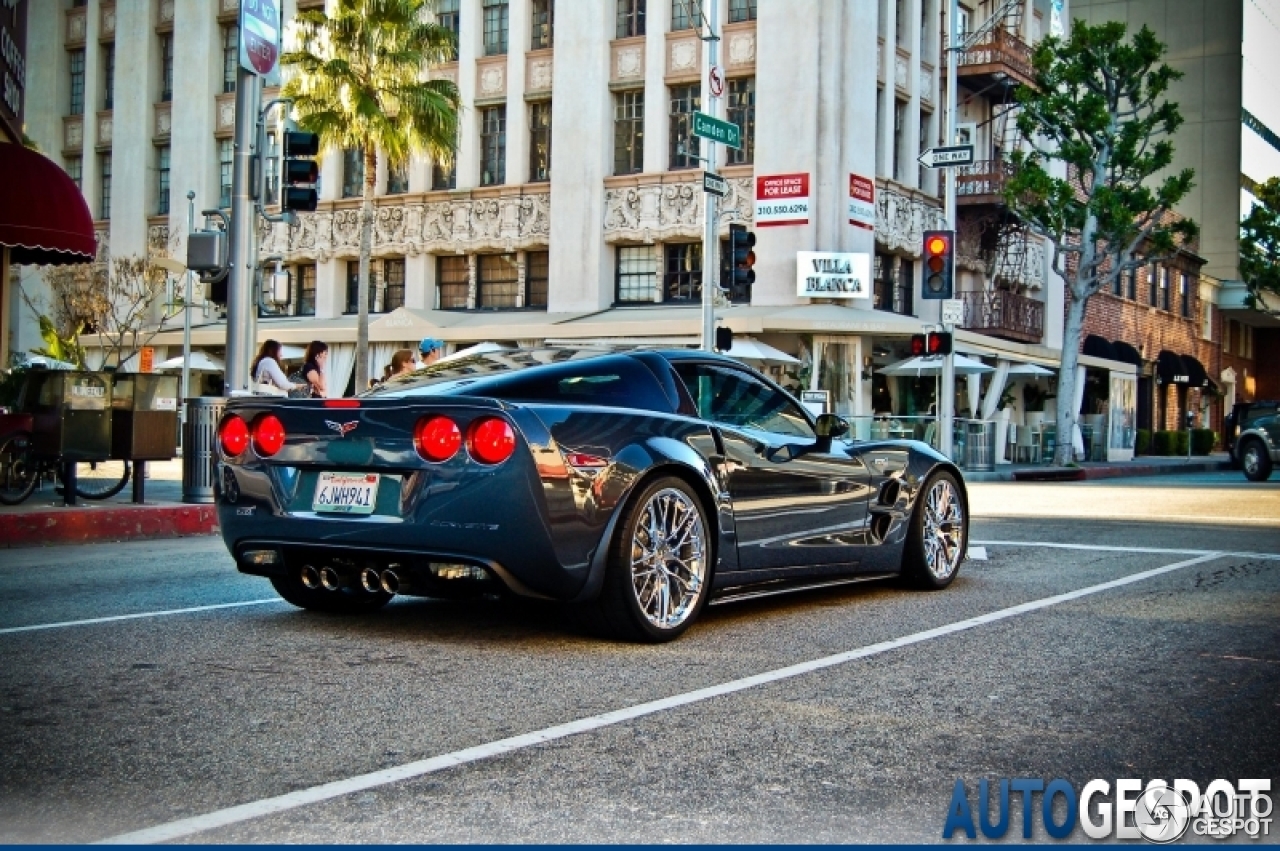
[218,352,960,600]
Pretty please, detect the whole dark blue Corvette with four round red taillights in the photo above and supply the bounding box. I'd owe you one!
[216,348,969,641]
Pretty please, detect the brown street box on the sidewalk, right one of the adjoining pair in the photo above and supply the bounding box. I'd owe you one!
[111,372,178,461]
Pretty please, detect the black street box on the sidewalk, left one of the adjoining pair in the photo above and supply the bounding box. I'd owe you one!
[24,370,111,462]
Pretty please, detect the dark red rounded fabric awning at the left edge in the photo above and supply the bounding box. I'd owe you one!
[0,145,97,265]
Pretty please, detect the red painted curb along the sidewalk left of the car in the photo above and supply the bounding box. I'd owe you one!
[0,505,218,546]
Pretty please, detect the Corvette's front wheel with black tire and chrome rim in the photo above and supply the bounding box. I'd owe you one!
[902,470,969,591]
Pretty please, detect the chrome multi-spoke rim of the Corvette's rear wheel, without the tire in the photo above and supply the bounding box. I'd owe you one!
[631,488,709,630]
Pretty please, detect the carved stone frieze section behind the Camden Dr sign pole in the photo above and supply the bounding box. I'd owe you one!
[604,171,755,243]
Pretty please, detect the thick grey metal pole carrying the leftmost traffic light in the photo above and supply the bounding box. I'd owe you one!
[224,67,262,395]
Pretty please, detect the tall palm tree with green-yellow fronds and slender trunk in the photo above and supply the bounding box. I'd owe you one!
[280,0,460,389]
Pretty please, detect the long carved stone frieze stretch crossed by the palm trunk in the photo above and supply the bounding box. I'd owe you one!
[259,192,550,262]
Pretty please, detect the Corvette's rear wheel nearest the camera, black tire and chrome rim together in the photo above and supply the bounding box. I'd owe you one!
[582,476,716,644]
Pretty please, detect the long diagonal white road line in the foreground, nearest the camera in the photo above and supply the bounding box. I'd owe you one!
[95,553,1221,845]
